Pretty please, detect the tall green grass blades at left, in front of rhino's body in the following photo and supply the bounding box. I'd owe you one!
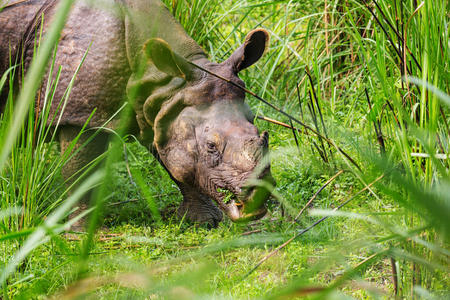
[0,1,99,299]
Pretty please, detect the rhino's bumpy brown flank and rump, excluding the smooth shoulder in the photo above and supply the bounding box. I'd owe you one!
[0,0,131,127]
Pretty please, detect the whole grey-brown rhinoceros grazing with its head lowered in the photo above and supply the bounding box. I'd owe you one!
[0,0,274,226]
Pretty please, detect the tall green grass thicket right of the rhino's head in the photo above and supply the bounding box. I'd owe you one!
[166,0,450,297]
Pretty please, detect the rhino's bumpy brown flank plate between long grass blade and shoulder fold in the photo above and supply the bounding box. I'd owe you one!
[35,1,131,128]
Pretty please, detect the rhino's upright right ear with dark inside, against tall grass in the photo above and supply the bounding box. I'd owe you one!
[224,28,269,73]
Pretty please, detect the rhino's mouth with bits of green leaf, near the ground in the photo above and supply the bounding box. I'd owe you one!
[216,171,275,222]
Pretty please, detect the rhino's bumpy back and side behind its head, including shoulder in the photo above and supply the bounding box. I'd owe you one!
[0,0,206,131]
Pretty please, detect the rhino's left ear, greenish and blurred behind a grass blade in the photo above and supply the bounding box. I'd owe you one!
[144,38,194,80]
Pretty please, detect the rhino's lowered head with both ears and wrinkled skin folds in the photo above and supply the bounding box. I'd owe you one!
[143,29,274,226]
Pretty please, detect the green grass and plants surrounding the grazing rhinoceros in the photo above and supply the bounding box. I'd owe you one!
[0,0,450,299]
